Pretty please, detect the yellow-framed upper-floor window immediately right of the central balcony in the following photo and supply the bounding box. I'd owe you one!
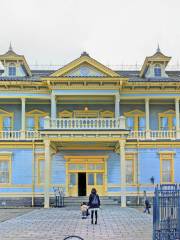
[124,110,146,131]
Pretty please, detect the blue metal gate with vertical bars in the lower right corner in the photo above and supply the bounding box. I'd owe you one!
[153,184,180,240]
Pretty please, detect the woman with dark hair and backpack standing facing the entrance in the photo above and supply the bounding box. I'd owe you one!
[88,188,100,224]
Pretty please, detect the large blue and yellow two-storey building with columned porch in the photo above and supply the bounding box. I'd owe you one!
[0,46,180,208]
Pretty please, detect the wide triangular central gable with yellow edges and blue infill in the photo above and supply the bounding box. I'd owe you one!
[50,52,120,77]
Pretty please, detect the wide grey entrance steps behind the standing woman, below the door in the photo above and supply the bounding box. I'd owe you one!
[64,196,119,206]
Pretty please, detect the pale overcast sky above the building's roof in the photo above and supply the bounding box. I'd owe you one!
[0,0,180,68]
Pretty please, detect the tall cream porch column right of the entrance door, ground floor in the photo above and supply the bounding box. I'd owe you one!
[119,140,126,207]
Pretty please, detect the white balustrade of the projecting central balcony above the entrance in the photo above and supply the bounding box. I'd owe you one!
[45,116,126,130]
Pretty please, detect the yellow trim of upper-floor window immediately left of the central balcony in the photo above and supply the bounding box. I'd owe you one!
[26,109,49,130]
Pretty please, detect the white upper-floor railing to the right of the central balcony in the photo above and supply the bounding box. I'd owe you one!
[128,130,177,140]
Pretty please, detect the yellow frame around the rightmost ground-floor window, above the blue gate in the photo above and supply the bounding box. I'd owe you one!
[160,152,174,184]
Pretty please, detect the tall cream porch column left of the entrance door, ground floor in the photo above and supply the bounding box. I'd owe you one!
[44,140,51,208]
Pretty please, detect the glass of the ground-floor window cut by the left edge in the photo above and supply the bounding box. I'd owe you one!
[0,160,10,183]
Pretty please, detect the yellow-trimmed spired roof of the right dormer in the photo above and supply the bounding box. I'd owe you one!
[140,45,171,77]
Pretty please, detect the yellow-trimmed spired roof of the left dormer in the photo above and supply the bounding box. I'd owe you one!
[0,44,32,76]
